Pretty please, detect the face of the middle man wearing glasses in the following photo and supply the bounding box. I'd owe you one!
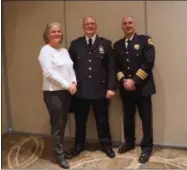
[83,17,97,36]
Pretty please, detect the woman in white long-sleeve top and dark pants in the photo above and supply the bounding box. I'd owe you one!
[38,23,76,169]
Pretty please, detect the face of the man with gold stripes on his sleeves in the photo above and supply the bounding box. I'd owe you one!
[122,17,135,35]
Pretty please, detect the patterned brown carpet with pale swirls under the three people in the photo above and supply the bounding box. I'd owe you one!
[2,134,187,169]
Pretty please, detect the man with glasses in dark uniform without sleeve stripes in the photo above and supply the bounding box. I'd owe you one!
[69,17,116,158]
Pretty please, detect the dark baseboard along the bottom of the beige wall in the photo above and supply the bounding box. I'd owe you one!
[7,131,187,149]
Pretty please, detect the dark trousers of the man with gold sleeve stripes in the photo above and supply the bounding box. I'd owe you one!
[121,90,153,149]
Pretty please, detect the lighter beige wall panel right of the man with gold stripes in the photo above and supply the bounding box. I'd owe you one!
[147,1,187,147]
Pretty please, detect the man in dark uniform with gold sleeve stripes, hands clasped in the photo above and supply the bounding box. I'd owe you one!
[114,17,156,163]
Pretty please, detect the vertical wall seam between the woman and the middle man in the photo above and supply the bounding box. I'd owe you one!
[63,0,71,137]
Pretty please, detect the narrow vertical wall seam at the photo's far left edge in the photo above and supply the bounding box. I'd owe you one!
[1,3,12,132]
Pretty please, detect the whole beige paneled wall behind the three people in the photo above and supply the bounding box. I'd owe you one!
[4,1,187,146]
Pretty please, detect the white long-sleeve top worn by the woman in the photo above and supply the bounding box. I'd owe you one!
[38,44,76,91]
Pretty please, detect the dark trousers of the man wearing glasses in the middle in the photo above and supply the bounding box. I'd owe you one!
[75,99,112,149]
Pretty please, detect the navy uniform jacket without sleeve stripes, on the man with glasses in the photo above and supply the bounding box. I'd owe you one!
[69,36,116,99]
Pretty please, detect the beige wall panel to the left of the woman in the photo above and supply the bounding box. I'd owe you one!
[4,1,69,135]
